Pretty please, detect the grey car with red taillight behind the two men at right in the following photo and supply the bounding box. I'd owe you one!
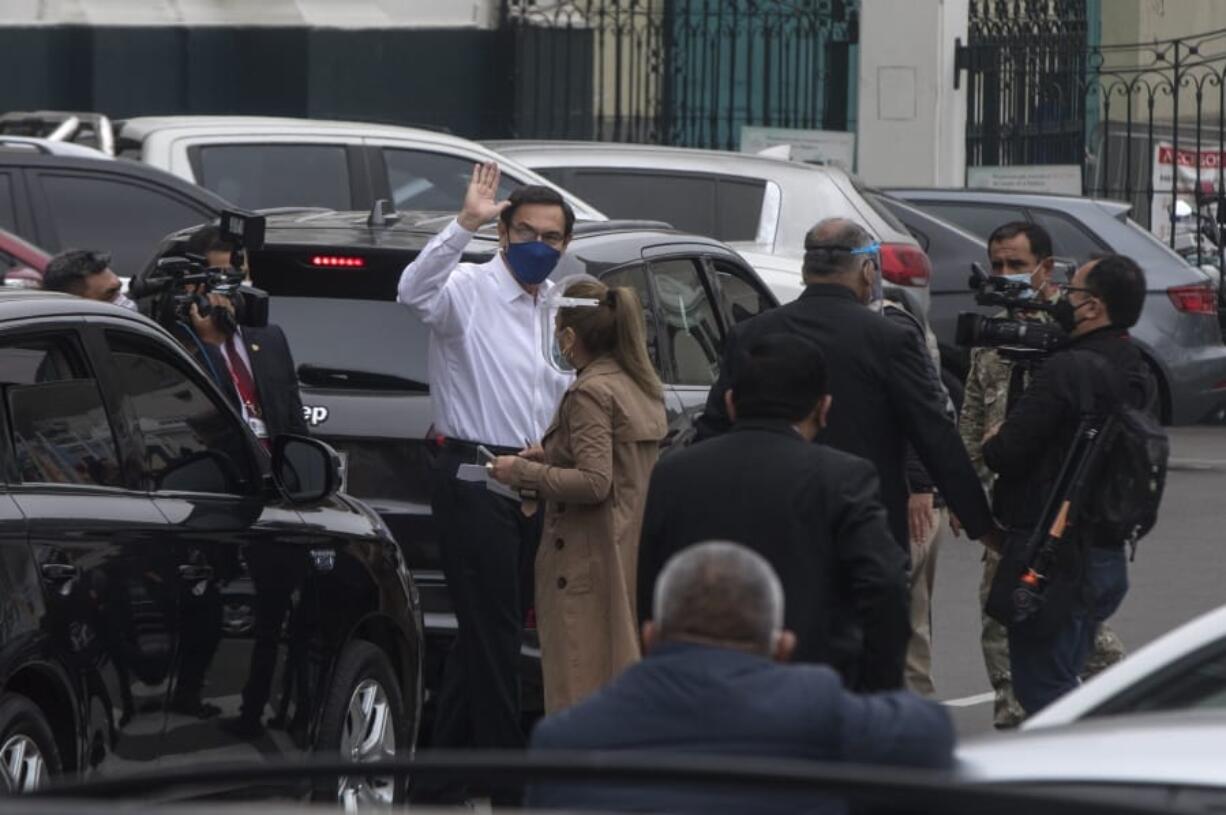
[886,189,1226,424]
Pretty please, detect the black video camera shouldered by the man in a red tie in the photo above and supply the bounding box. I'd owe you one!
[129,210,268,335]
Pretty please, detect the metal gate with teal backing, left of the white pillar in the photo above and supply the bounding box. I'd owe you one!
[501,0,857,150]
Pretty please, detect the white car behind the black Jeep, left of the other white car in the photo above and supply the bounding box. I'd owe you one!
[115,116,604,221]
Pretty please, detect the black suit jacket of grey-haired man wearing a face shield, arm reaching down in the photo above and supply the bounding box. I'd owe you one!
[698,283,994,550]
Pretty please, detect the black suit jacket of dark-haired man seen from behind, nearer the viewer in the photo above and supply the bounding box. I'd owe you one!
[638,420,911,690]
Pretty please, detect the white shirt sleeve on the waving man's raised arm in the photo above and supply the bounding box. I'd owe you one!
[396,221,473,333]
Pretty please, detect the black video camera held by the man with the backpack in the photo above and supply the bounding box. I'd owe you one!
[954,263,1068,358]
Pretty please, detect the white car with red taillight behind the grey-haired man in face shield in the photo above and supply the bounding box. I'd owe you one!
[485,141,932,313]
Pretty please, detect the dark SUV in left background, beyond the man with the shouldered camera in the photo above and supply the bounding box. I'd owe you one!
[0,142,233,277]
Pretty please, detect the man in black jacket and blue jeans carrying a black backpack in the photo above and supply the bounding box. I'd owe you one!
[982,255,1165,713]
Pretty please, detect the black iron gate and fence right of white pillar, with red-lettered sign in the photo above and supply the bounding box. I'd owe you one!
[955,0,1226,266]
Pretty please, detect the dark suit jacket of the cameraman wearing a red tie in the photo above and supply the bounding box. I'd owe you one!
[199,325,310,438]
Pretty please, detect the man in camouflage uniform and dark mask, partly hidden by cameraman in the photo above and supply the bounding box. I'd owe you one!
[958,221,1124,729]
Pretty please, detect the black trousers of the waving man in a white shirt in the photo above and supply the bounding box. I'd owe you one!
[433,447,542,749]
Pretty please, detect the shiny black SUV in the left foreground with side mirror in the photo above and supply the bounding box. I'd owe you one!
[0,289,423,800]
